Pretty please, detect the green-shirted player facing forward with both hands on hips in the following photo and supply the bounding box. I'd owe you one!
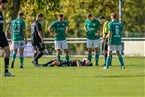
[48,14,69,61]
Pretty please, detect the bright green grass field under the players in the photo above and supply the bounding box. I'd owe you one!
[0,58,145,97]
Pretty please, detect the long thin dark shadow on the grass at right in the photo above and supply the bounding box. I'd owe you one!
[96,75,145,78]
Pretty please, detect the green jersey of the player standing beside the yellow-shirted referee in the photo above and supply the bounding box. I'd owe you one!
[85,19,102,40]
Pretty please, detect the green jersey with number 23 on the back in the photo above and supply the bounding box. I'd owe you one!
[11,18,26,41]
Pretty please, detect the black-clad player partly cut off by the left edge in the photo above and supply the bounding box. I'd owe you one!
[0,0,14,77]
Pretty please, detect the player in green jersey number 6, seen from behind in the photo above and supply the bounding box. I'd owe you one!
[103,13,125,69]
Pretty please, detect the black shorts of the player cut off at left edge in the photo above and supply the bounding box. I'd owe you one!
[0,32,9,48]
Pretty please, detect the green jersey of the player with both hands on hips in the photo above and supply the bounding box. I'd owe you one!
[50,21,68,41]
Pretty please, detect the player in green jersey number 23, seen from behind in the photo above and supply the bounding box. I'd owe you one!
[11,11,27,68]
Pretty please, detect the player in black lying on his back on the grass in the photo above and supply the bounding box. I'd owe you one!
[37,58,93,67]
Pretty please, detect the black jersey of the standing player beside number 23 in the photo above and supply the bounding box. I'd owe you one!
[31,20,42,44]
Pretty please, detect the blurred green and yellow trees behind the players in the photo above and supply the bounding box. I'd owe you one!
[4,0,145,54]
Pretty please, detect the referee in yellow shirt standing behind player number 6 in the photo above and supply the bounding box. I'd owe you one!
[99,16,112,66]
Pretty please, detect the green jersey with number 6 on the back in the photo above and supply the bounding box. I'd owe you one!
[109,20,123,45]
